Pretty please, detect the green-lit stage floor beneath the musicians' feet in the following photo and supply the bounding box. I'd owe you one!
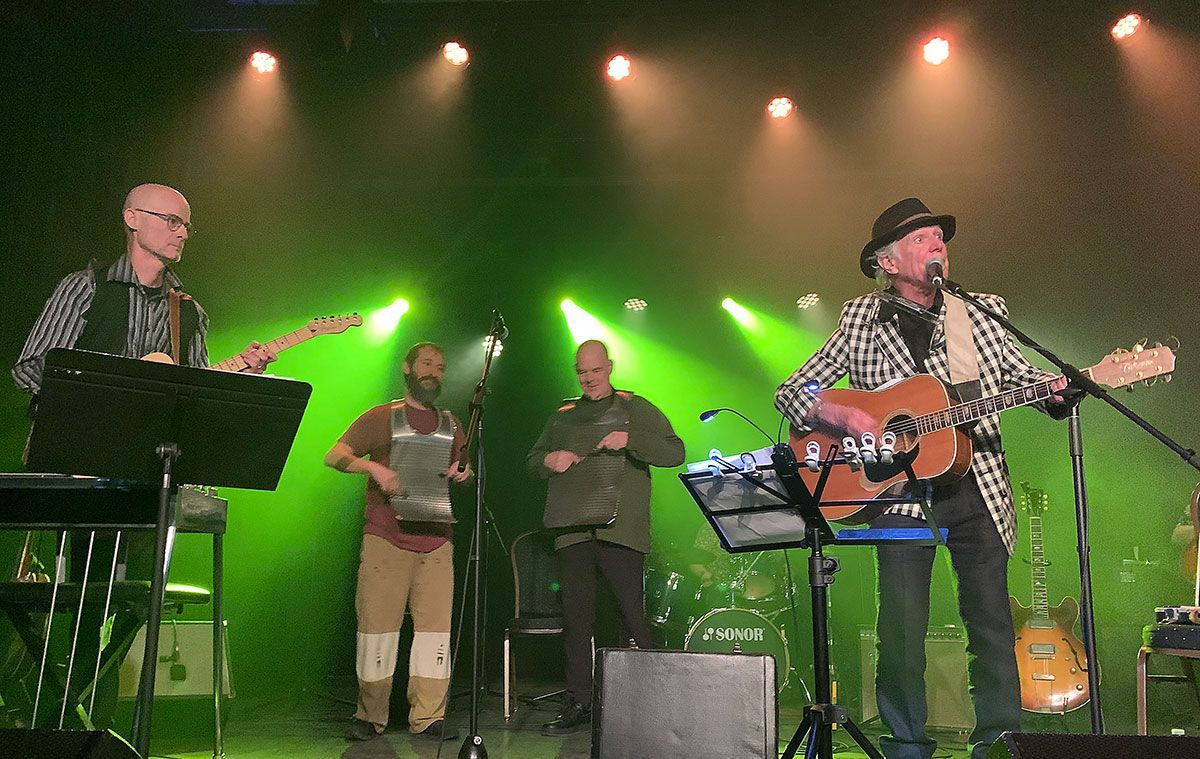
[151,691,967,759]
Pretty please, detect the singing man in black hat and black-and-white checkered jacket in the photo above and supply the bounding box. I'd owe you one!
[775,198,1066,759]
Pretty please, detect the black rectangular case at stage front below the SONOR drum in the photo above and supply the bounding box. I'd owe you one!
[592,649,779,759]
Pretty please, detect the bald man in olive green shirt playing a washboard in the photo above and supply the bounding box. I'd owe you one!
[527,340,684,735]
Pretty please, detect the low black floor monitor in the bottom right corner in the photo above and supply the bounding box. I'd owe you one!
[988,733,1200,759]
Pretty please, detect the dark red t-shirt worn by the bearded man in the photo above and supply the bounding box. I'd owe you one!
[340,404,466,554]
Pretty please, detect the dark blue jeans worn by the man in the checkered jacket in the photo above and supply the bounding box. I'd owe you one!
[871,474,1021,759]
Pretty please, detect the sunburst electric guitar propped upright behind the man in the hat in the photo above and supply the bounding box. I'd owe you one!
[1008,483,1092,715]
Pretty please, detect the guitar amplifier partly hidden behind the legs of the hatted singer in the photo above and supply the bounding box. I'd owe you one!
[858,626,974,733]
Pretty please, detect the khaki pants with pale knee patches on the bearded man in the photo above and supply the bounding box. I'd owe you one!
[354,534,454,733]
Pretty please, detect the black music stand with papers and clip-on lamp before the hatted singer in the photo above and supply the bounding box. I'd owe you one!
[679,444,946,759]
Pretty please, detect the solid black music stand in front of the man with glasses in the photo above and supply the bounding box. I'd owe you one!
[26,348,312,757]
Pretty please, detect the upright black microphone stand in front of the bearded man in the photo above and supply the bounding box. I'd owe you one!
[458,311,508,759]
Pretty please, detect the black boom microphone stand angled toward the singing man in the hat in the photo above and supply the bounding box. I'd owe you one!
[937,277,1200,735]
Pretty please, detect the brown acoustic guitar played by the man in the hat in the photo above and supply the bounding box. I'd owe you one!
[790,343,1175,525]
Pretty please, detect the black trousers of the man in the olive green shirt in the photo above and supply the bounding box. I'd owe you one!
[558,539,652,706]
